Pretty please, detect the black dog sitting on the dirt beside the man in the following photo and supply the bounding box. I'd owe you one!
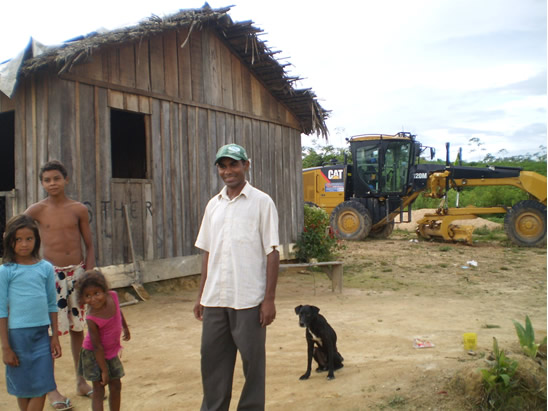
[295,305,344,380]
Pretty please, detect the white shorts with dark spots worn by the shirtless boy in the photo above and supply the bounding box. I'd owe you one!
[53,263,86,335]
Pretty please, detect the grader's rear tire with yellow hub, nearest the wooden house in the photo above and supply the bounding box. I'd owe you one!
[331,201,372,241]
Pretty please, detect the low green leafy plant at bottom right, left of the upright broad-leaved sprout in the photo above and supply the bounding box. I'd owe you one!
[480,337,518,409]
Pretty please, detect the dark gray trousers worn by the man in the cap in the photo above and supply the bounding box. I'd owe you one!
[201,307,266,411]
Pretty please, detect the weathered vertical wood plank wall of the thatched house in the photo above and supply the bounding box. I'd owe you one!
[0,30,302,266]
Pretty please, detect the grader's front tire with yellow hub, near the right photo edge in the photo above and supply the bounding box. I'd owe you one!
[504,200,546,247]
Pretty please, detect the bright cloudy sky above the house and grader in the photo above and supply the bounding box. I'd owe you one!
[0,0,548,161]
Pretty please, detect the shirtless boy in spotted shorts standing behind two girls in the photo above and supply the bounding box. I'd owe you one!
[25,160,95,410]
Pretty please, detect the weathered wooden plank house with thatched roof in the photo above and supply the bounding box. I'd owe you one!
[0,5,327,286]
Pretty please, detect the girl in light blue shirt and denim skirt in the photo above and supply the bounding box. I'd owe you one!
[0,215,61,411]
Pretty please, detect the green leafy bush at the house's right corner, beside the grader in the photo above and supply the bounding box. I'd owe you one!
[295,205,342,261]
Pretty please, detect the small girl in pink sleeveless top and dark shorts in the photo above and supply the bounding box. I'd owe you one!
[77,270,131,411]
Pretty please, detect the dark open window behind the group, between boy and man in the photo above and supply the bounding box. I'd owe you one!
[110,109,149,179]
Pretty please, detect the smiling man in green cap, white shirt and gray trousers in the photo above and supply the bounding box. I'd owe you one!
[194,144,280,411]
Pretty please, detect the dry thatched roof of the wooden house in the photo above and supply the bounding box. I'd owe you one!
[13,3,328,137]
